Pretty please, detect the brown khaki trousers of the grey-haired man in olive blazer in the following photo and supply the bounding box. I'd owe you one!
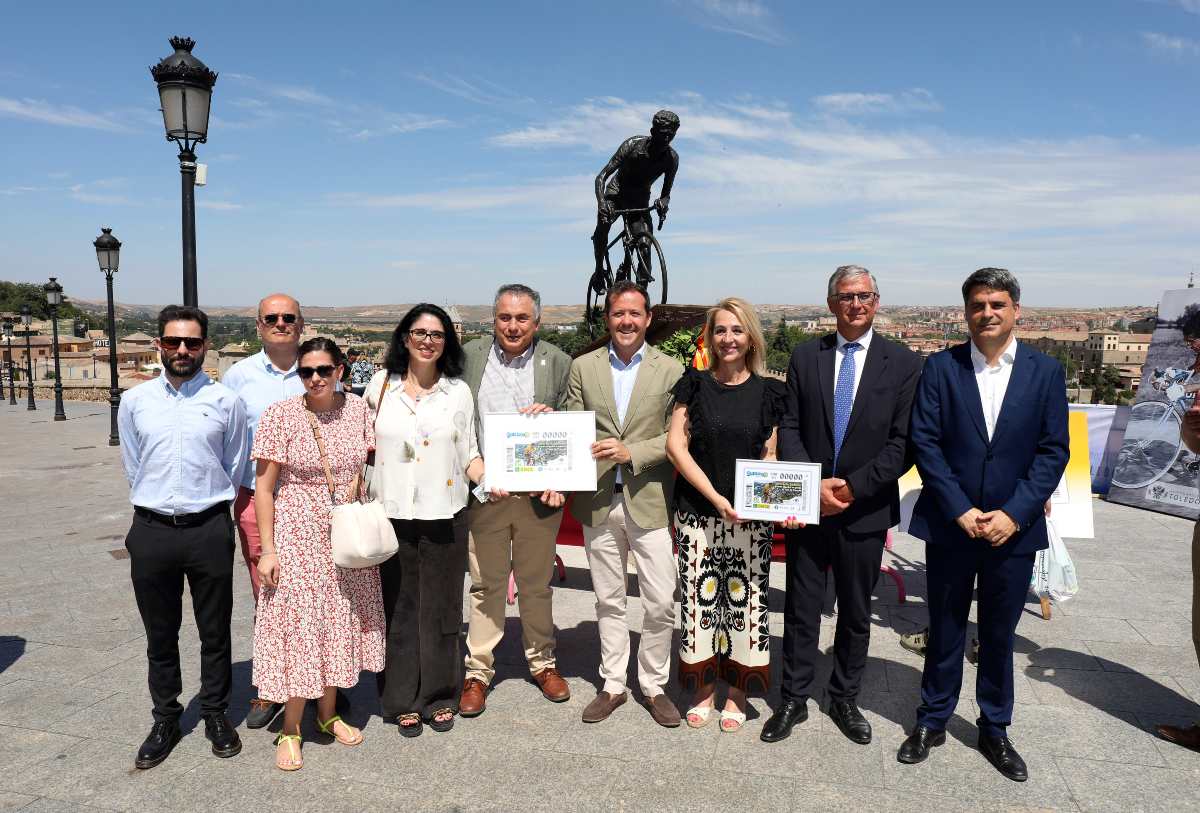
[466,494,563,686]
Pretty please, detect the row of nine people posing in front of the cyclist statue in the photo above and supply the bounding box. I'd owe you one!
[120,265,1068,781]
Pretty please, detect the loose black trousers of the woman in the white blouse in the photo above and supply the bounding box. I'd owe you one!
[377,511,467,721]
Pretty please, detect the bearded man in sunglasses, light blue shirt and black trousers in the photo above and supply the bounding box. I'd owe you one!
[118,306,248,769]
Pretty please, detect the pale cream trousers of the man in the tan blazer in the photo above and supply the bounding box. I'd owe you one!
[583,494,679,698]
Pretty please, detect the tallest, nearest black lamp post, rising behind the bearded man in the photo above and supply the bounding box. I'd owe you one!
[150,37,217,307]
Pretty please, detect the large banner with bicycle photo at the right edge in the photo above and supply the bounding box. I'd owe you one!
[1109,288,1200,519]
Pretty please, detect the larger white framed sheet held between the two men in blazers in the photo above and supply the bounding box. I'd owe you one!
[484,412,596,492]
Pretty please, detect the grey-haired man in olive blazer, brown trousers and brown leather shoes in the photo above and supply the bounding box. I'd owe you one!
[458,284,571,717]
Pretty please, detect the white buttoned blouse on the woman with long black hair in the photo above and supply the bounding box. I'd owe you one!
[365,369,479,519]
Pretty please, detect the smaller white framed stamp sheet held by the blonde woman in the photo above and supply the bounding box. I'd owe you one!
[733,459,821,525]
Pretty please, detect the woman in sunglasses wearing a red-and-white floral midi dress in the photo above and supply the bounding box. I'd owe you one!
[251,338,384,771]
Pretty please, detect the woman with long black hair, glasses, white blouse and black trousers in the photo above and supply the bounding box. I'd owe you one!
[366,303,484,736]
